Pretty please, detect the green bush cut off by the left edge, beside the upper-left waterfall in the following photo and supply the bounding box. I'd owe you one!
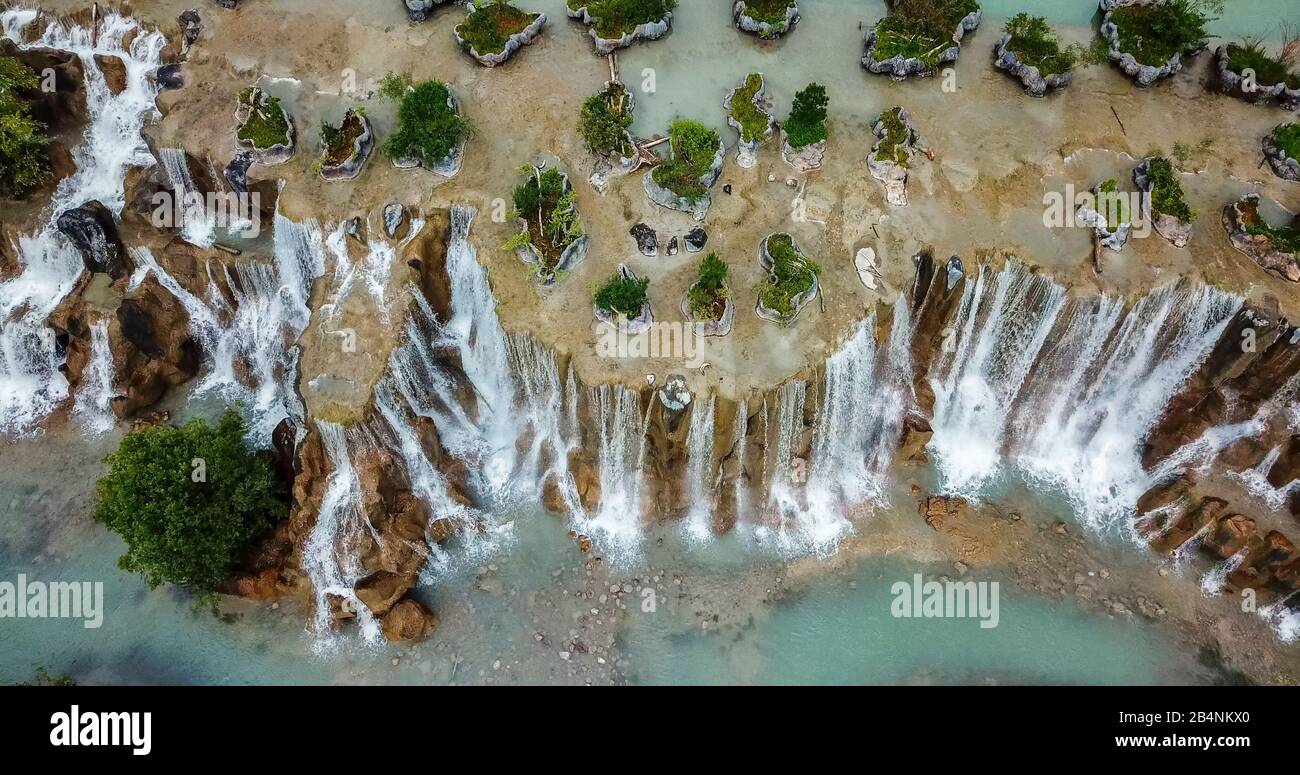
[0,56,51,198]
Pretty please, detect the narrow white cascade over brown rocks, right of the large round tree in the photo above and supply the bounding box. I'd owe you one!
[303,420,380,649]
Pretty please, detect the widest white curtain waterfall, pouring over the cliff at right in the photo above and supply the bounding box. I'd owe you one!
[930,261,1242,528]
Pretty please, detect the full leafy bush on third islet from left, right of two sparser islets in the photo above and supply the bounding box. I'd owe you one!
[380,74,469,166]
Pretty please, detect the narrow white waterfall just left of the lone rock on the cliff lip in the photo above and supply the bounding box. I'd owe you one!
[576,385,650,557]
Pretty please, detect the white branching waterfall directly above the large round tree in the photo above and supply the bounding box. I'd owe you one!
[131,213,324,446]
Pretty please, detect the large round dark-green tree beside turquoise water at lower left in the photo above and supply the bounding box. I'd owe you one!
[95,411,289,593]
